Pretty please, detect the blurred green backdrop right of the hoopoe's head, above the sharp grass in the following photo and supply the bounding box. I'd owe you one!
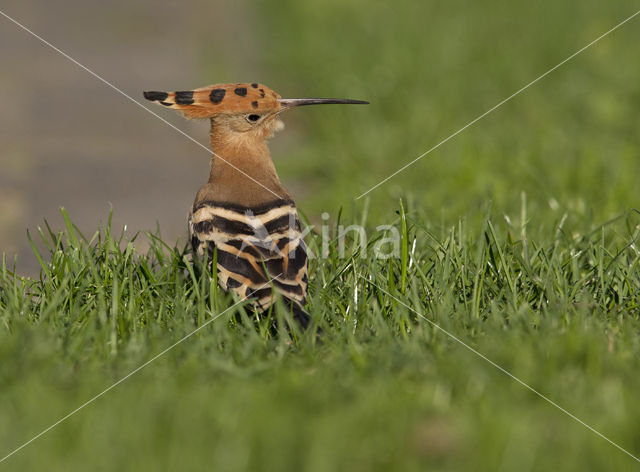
[262,1,640,229]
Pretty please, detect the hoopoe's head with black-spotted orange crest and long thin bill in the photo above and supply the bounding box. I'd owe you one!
[144,82,368,146]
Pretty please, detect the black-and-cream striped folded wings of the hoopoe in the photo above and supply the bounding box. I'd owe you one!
[189,201,308,316]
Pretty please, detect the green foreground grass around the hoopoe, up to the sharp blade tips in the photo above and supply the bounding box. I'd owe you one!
[0,205,640,470]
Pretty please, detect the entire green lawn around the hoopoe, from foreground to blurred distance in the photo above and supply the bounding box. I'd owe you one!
[0,0,640,471]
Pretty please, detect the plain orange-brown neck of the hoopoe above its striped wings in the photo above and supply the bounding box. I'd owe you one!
[196,120,291,207]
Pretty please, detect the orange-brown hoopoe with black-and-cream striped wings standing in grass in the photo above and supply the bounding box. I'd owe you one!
[144,83,368,327]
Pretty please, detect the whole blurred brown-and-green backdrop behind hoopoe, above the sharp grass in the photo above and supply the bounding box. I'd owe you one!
[0,1,640,273]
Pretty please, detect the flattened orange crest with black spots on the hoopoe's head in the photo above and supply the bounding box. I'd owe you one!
[144,82,281,118]
